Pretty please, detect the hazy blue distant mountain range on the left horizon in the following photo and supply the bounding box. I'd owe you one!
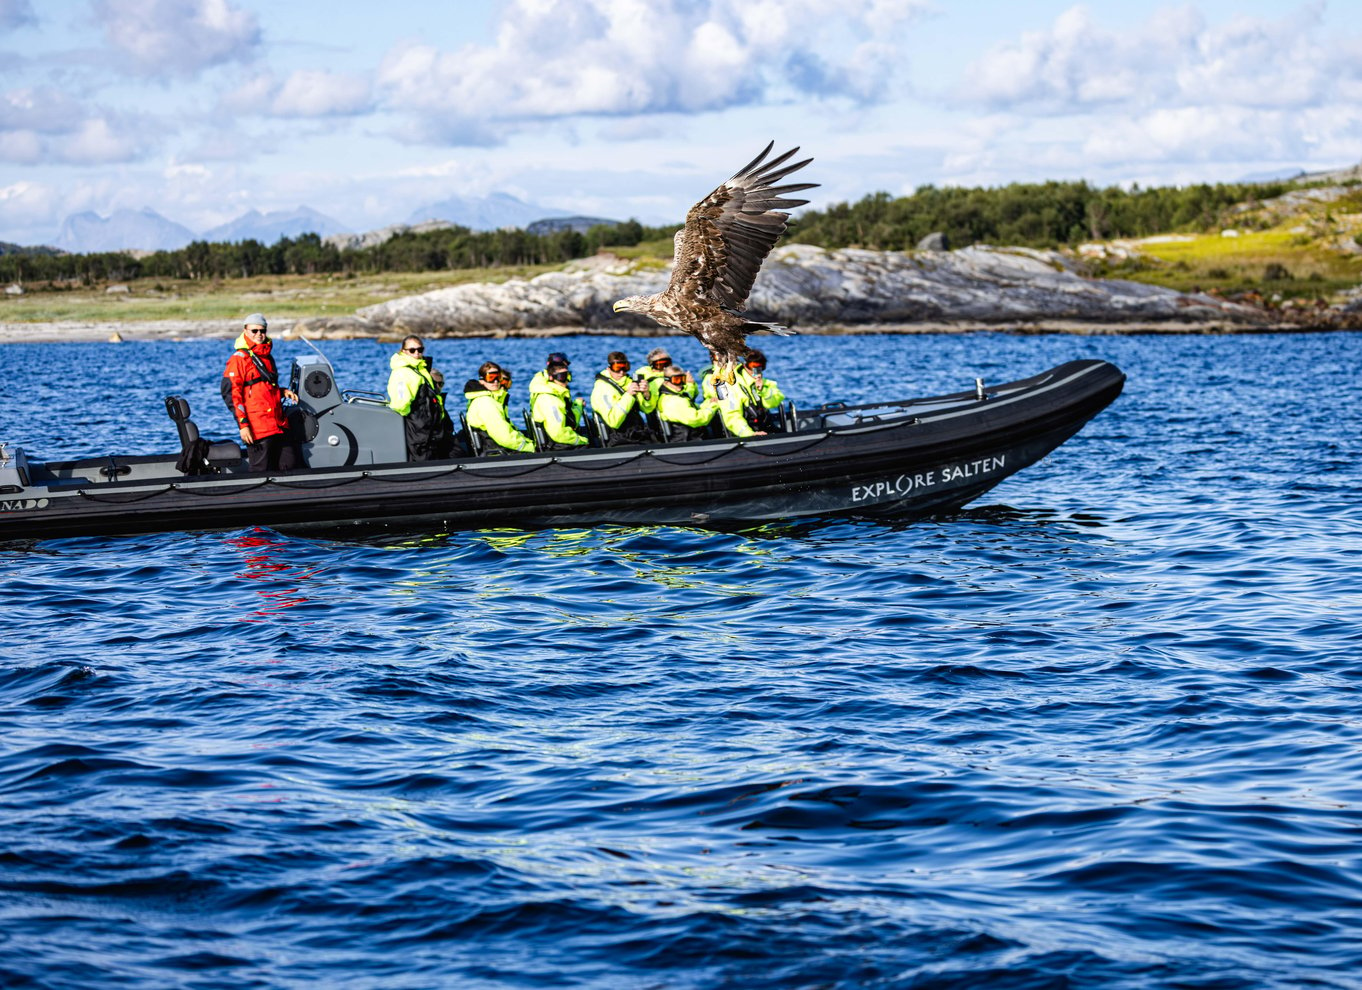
[29,192,614,255]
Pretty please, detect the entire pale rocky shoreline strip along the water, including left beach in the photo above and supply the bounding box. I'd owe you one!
[0,244,1362,343]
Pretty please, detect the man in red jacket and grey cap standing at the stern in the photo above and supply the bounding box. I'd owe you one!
[223,313,298,471]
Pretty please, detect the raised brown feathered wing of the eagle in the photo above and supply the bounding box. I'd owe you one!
[665,142,817,312]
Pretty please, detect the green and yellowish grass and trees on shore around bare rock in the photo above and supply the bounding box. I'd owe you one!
[0,166,1362,342]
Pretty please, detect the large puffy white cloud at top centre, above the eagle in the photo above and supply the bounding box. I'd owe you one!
[377,0,925,143]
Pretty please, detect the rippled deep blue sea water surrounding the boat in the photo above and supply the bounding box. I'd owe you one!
[0,334,1362,990]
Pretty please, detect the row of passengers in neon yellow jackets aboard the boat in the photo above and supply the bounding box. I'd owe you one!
[388,336,785,460]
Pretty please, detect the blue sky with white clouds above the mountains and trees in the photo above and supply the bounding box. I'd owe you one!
[0,0,1362,244]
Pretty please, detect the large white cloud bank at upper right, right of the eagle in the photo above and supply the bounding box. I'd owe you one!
[926,5,1362,184]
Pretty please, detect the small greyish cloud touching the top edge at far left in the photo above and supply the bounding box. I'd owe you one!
[94,0,260,78]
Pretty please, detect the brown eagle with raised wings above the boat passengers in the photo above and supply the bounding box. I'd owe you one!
[614,142,817,383]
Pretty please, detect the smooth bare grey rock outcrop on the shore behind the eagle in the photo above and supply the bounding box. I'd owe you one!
[335,244,1272,335]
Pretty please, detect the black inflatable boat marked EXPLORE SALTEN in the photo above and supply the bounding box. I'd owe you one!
[0,355,1125,539]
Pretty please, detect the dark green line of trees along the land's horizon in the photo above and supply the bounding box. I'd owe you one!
[0,181,1293,285]
